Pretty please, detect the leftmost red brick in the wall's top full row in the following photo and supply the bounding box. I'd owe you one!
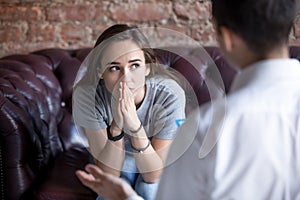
[0,6,42,22]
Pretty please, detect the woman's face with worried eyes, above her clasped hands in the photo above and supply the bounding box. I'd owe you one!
[99,40,150,93]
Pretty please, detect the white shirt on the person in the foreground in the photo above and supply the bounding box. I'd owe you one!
[157,59,300,200]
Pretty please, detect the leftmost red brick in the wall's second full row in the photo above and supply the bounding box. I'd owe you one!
[0,25,25,43]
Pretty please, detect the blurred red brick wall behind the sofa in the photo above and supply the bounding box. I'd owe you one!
[0,0,300,57]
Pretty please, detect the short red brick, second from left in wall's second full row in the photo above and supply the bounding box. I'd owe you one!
[27,24,56,42]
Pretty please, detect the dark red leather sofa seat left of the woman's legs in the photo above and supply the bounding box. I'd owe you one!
[25,147,97,200]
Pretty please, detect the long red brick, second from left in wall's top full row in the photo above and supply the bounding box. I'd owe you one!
[46,5,105,21]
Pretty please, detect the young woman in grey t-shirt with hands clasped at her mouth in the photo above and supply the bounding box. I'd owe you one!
[73,24,185,199]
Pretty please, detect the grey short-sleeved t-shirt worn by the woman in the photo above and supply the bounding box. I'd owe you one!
[73,76,185,139]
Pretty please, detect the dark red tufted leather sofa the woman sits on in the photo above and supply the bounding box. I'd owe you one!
[0,46,300,200]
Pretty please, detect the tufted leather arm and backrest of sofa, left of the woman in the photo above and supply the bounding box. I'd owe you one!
[0,49,90,199]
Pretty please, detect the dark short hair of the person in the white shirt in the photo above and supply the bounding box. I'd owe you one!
[212,0,297,54]
